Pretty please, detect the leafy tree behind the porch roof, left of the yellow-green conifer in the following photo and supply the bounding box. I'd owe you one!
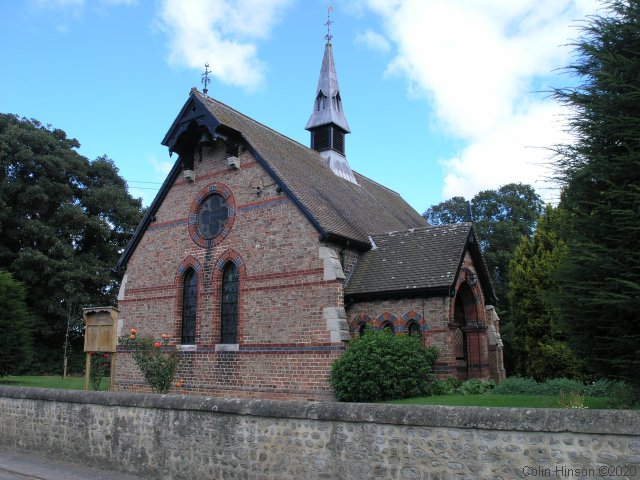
[423,183,544,372]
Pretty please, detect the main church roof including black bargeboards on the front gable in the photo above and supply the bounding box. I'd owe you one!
[116,89,427,270]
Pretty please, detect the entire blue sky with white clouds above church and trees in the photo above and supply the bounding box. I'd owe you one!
[0,0,598,212]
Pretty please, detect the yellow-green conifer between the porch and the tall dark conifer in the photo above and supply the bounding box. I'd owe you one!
[509,206,581,381]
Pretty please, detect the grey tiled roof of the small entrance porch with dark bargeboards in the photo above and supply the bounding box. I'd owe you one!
[345,223,495,304]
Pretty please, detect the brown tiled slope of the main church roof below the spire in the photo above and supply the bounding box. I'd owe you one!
[192,91,426,243]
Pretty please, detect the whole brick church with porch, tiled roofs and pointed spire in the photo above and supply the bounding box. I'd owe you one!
[115,37,504,400]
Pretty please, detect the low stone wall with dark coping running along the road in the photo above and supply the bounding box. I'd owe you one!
[0,387,640,480]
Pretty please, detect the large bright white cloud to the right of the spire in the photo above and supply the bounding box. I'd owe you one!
[344,0,597,202]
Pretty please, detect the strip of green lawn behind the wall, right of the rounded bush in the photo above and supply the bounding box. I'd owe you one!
[387,393,612,408]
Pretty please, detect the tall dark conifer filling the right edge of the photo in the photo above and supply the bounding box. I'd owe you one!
[554,0,640,385]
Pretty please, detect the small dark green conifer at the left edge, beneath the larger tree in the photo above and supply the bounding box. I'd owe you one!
[0,270,33,377]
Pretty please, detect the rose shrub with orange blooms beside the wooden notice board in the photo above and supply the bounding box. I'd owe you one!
[120,328,180,393]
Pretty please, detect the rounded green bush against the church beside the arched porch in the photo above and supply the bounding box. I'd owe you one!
[329,330,438,402]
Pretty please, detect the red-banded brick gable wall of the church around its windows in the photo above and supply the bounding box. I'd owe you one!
[116,142,344,399]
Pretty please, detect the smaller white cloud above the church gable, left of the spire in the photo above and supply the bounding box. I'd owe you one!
[158,0,291,90]
